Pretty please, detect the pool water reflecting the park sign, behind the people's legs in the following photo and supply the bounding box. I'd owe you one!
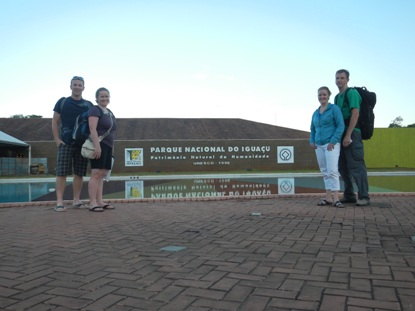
[0,175,415,203]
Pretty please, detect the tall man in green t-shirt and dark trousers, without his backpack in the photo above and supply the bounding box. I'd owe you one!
[335,69,370,206]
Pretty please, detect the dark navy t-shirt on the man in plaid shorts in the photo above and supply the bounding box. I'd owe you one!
[53,97,94,144]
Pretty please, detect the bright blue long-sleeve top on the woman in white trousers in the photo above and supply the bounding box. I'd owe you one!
[310,103,344,145]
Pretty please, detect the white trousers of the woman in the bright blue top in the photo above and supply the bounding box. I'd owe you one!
[316,143,340,191]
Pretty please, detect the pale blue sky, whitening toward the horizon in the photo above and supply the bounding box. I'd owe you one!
[0,0,415,131]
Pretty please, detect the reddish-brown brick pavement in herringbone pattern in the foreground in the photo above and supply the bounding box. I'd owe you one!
[0,195,415,311]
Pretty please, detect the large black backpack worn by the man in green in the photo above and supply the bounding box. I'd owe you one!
[334,86,376,140]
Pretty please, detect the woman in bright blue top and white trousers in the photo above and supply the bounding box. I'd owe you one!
[310,86,344,207]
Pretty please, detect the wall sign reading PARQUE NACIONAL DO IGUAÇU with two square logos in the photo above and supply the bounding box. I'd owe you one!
[120,140,315,172]
